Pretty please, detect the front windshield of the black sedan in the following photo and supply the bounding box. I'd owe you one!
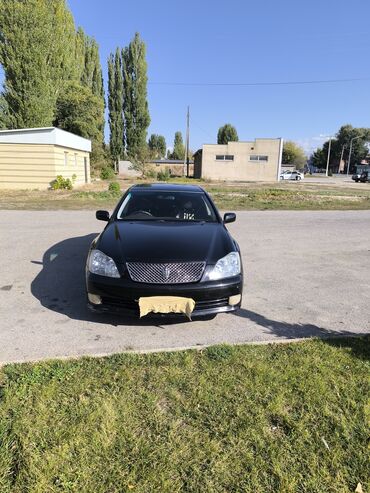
[117,191,217,222]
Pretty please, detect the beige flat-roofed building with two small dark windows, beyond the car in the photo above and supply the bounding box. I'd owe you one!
[194,139,283,181]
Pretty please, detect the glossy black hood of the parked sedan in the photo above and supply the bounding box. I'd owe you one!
[95,221,235,264]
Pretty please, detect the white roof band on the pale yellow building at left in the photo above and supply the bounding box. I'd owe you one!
[0,127,91,152]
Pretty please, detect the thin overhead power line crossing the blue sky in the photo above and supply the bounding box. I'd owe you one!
[148,77,370,87]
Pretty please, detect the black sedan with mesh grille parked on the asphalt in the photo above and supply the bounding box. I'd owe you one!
[86,184,243,316]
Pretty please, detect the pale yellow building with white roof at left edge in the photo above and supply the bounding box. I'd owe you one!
[0,127,91,189]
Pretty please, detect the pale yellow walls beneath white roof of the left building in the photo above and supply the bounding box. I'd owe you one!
[0,143,90,190]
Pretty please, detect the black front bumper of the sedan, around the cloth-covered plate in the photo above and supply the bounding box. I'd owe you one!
[86,272,243,318]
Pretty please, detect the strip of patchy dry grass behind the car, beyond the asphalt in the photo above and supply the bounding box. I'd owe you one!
[0,183,370,210]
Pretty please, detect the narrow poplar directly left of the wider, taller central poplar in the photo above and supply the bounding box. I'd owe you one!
[108,48,124,163]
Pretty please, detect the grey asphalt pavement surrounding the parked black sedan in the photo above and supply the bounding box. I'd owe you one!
[0,211,370,363]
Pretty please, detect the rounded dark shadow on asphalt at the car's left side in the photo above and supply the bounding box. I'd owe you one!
[31,233,188,326]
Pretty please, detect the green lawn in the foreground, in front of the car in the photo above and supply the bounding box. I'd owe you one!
[0,338,370,493]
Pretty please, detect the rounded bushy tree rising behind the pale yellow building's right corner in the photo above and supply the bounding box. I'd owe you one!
[54,81,106,170]
